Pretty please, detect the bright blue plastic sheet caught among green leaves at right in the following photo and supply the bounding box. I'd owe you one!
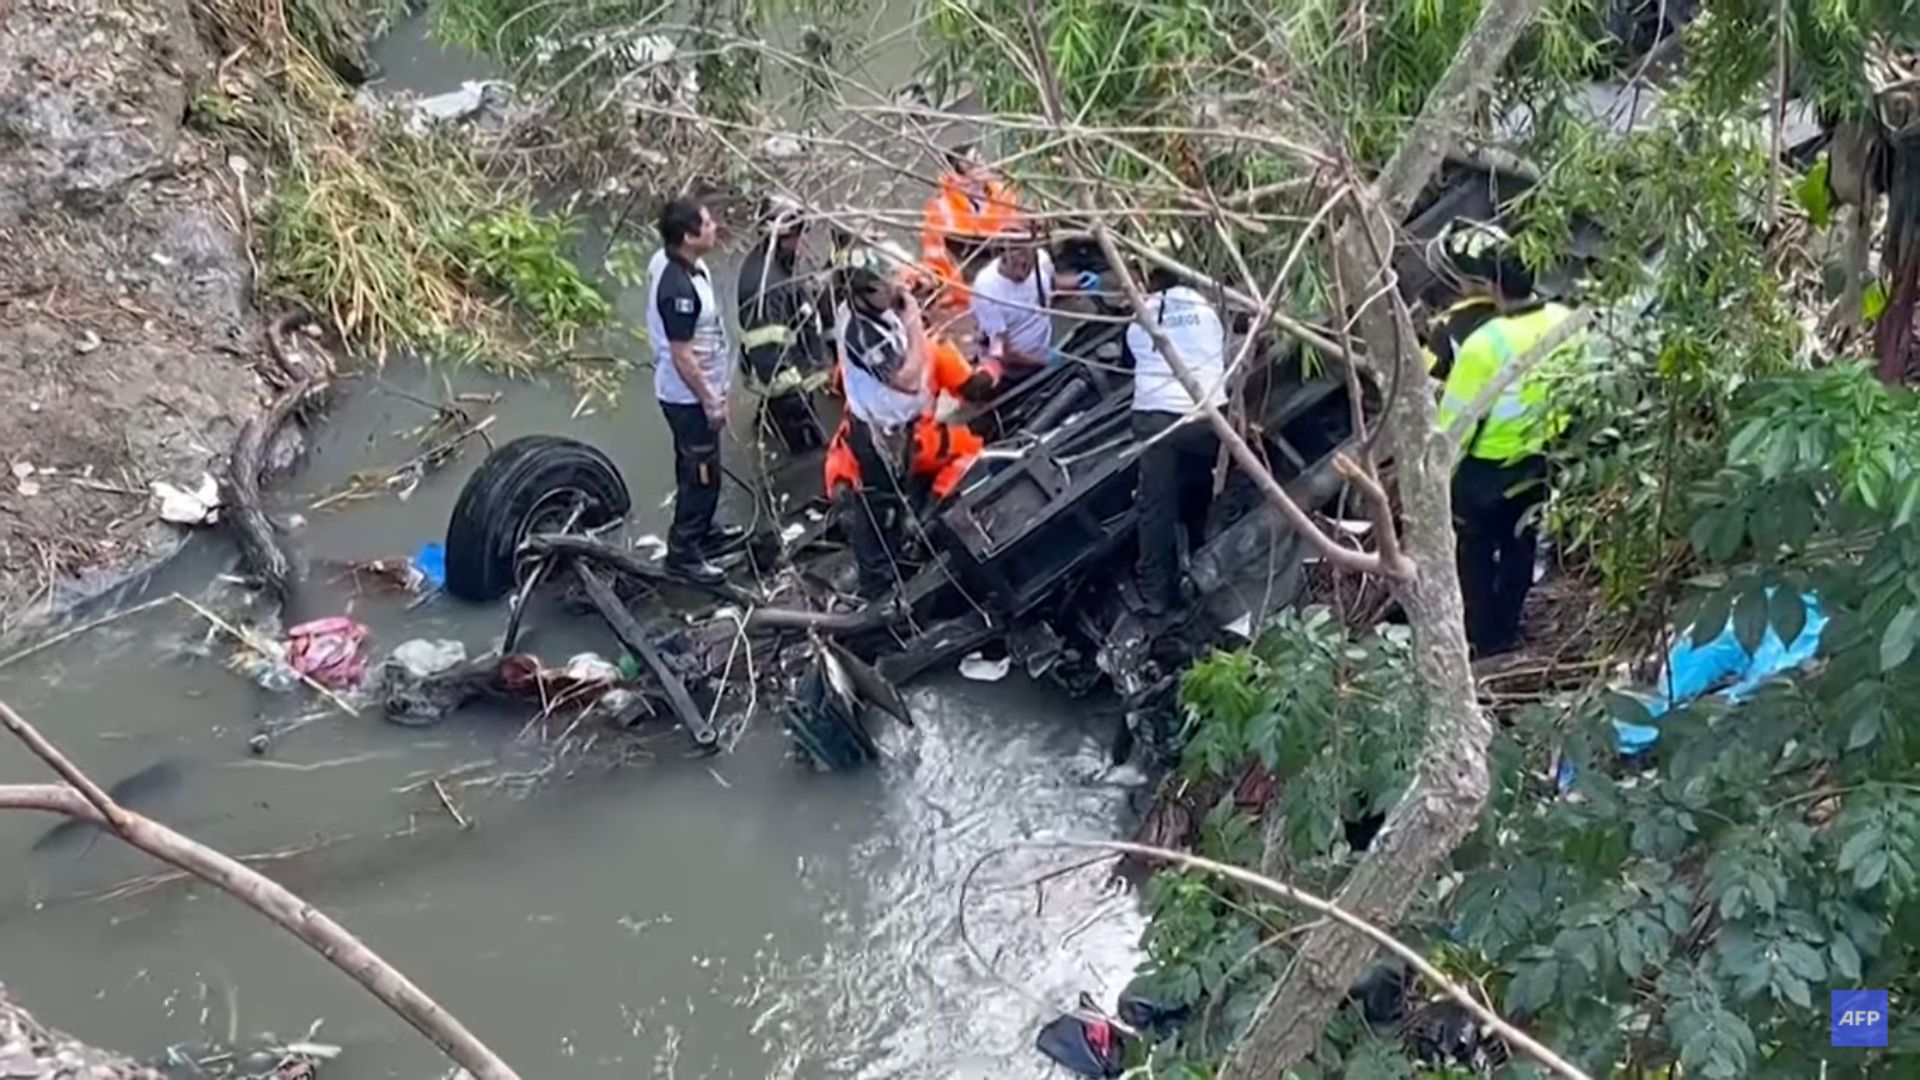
[1559,588,1826,788]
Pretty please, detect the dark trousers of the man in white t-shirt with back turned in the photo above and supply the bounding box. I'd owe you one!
[1133,413,1219,607]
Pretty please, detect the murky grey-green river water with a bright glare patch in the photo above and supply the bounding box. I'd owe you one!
[0,10,1140,1080]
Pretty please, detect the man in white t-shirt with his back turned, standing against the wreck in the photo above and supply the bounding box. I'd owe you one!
[1127,267,1227,615]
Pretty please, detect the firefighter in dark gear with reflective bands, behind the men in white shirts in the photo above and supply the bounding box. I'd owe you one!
[737,196,826,454]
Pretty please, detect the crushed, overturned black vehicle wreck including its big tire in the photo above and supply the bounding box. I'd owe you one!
[412,161,1643,767]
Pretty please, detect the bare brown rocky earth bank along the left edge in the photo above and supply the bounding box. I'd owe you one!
[0,0,263,632]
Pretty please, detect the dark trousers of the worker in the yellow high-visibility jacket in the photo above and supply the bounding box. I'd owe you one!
[1453,455,1548,655]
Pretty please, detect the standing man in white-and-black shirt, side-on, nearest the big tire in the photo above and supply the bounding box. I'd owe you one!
[647,198,745,584]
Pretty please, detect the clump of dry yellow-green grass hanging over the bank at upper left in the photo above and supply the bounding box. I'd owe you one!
[194,0,611,377]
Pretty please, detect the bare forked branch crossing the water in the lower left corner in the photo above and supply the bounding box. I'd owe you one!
[0,703,518,1080]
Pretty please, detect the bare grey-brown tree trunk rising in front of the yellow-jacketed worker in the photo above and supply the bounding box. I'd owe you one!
[1221,0,1540,1080]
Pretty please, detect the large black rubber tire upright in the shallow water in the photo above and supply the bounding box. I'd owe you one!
[447,434,632,601]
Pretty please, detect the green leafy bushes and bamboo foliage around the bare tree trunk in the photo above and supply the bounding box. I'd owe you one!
[910,0,1920,1080]
